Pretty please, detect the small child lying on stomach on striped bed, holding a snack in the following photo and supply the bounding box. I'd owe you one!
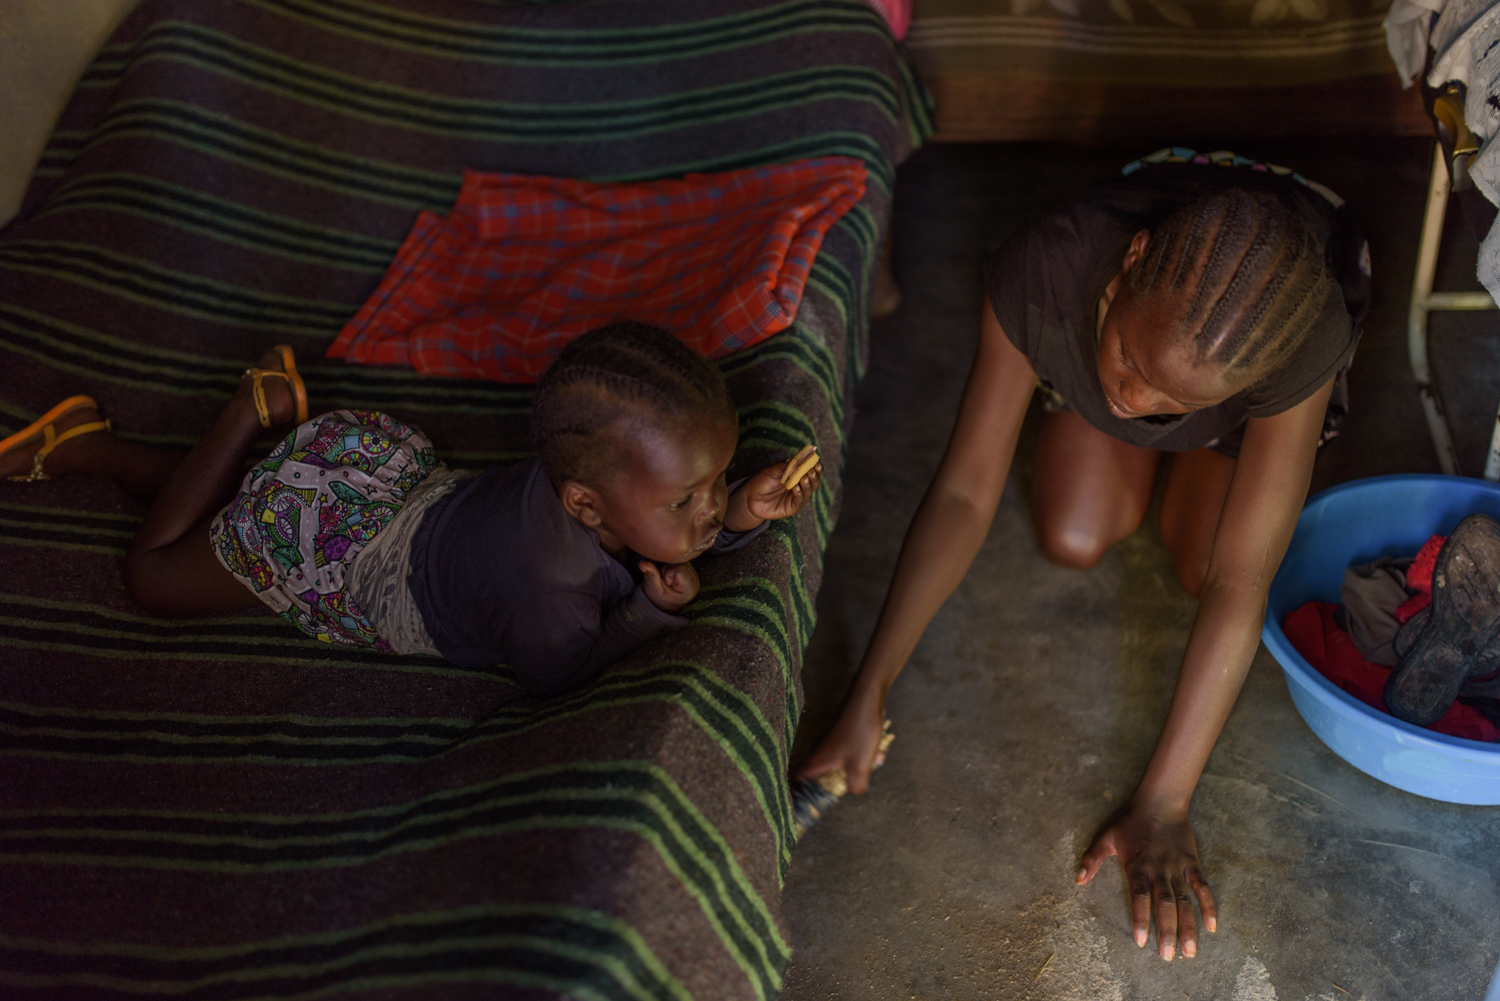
[0,323,822,696]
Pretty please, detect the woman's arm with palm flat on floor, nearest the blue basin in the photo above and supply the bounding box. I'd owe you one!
[1079,381,1334,959]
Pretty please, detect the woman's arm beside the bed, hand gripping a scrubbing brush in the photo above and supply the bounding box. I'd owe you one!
[800,302,1037,792]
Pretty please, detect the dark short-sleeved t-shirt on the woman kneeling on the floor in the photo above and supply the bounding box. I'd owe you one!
[984,164,1370,452]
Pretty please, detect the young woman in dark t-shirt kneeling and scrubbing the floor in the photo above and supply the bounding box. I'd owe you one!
[801,150,1370,960]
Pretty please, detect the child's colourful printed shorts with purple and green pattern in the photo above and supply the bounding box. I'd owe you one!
[209,410,438,651]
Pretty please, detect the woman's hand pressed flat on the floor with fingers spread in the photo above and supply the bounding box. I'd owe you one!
[1079,804,1218,962]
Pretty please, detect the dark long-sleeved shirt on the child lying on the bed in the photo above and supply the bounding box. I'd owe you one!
[407,459,765,698]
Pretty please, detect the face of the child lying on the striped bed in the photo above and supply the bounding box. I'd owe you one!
[594,422,740,563]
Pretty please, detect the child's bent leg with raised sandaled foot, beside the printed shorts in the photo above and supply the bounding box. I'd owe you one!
[125,351,294,615]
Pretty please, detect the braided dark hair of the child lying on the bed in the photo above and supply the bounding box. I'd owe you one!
[531,321,737,485]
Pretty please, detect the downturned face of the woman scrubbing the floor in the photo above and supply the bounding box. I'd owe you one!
[1098,230,1238,420]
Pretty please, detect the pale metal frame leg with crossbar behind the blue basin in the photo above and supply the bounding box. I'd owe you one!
[1407,143,1500,480]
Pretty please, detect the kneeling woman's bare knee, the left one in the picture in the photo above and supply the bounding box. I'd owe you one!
[1032,410,1161,570]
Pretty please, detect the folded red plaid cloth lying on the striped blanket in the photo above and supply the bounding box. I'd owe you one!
[329,156,866,383]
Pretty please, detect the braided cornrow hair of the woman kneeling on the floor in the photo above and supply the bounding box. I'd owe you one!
[1125,188,1343,384]
